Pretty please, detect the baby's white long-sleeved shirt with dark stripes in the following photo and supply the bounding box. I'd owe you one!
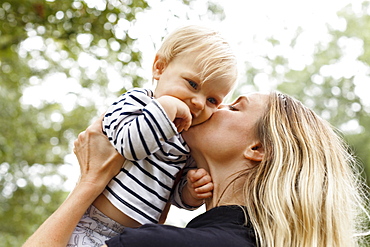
[103,88,189,224]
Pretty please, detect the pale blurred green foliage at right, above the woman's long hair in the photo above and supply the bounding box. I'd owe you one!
[240,1,370,187]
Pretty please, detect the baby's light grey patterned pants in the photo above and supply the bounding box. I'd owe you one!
[67,205,124,247]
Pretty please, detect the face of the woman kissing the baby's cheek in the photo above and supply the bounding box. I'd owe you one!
[183,93,269,162]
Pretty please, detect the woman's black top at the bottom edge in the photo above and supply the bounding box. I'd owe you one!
[106,206,256,247]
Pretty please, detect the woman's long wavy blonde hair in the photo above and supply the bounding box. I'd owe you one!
[244,93,369,247]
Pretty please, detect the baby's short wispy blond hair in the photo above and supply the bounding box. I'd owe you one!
[157,25,237,88]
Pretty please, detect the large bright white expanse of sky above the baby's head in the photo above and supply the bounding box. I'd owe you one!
[135,0,361,80]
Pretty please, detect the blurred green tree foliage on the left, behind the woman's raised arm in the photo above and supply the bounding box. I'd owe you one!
[0,0,222,246]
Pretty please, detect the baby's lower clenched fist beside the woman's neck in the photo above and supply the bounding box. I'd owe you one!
[181,168,213,207]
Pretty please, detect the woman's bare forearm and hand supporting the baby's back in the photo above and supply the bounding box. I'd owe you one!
[23,117,124,247]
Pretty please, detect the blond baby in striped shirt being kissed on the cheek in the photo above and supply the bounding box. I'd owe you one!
[69,26,237,246]
